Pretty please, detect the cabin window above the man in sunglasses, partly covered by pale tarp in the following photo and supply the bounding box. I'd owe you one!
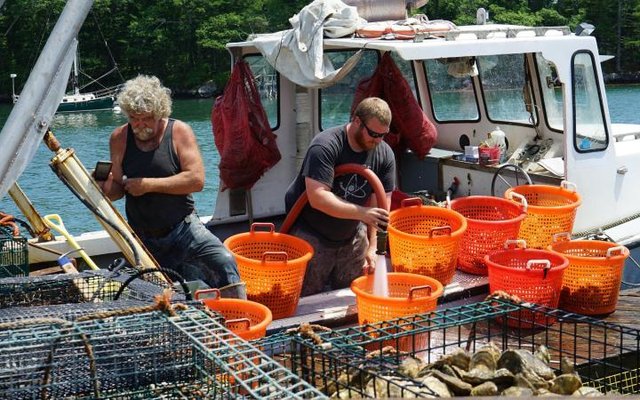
[320,50,379,130]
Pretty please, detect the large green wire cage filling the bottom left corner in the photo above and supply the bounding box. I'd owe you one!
[0,306,322,399]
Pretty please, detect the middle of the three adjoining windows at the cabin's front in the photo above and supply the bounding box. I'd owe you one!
[476,54,536,125]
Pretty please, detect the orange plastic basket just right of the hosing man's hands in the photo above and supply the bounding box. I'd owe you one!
[387,198,467,285]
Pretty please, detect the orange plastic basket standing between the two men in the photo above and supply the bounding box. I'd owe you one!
[224,222,313,319]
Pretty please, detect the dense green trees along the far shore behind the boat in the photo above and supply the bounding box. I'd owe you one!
[0,0,640,99]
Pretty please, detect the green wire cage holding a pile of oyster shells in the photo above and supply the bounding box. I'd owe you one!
[261,299,640,398]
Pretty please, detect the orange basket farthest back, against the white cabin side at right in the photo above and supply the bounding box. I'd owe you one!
[504,181,582,249]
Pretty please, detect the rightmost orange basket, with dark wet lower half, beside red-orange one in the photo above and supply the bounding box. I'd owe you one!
[549,234,629,315]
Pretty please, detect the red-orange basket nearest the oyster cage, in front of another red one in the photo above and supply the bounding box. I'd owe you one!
[485,240,569,326]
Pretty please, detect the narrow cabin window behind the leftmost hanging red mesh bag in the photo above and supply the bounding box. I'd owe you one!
[244,55,280,129]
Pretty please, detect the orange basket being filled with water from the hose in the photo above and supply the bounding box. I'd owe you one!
[351,272,444,351]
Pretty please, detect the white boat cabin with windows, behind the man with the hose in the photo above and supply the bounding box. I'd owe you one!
[211,18,640,250]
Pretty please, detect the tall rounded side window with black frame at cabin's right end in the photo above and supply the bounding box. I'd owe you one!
[572,52,609,153]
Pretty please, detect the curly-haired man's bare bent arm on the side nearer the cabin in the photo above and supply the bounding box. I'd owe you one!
[124,120,204,196]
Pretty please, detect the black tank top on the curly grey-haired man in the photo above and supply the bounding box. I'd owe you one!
[122,119,193,231]
